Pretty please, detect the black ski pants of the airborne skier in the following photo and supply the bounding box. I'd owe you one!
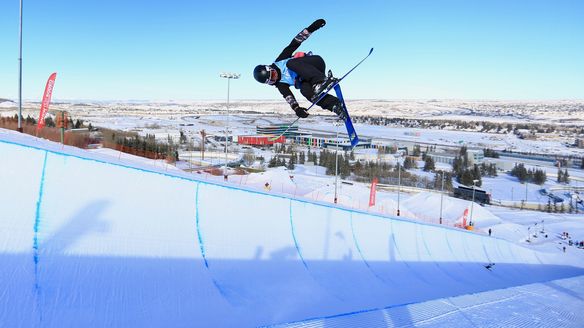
[286,56,339,111]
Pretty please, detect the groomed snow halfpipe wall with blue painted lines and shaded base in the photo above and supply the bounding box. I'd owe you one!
[0,130,584,327]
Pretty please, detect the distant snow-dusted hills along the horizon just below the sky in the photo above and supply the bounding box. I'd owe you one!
[0,98,584,124]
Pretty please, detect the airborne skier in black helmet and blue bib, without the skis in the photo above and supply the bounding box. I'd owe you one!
[253,19,345,120]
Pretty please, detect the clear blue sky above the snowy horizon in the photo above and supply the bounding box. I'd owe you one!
[0,0,584,100]
